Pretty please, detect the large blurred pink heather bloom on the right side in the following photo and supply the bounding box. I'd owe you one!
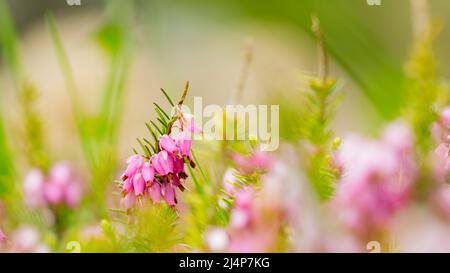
[335,124,416,235]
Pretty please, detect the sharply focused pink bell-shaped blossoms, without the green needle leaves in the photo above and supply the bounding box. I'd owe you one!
[121,111,200,209]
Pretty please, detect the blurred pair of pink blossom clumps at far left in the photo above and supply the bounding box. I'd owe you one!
[24,162,84,208]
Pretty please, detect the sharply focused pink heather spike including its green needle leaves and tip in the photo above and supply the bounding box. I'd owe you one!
[121,82,200,209]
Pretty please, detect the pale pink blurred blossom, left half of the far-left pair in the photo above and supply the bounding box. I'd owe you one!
[23,169,45,208]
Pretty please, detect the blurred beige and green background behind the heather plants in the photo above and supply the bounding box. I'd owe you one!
[1,0,450,164]
